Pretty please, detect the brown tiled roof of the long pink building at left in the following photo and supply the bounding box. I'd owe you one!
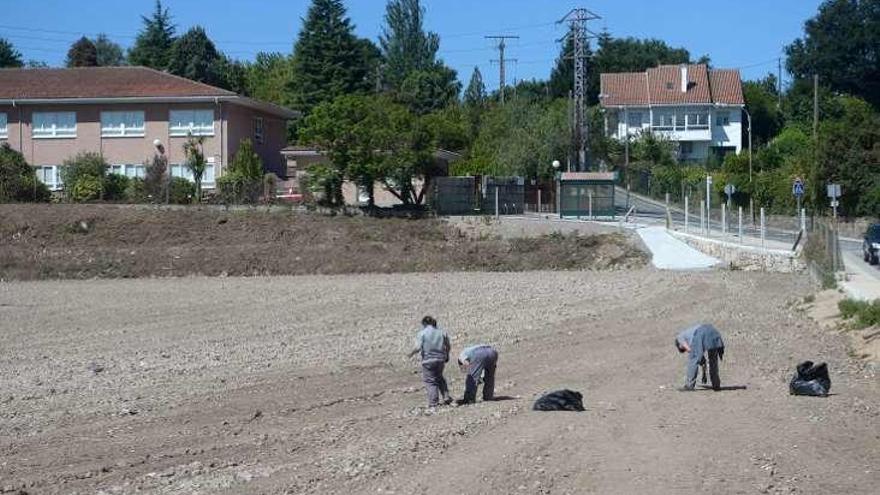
[0,67,235,100]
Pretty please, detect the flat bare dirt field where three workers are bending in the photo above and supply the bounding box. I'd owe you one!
[0,269,880,494]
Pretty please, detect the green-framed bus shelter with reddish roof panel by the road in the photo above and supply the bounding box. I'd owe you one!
[556,172,617,218]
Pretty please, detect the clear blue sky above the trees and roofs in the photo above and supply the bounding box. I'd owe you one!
[0,0,821,89]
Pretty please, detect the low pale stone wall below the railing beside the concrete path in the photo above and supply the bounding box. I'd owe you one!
[668,230,807,273]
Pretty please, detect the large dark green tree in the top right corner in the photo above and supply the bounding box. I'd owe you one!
[785,0,880,108]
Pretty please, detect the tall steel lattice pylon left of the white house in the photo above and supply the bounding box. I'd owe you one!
[557,8,601,172]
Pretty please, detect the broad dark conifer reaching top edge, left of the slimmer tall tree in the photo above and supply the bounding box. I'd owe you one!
[287,0,375,113]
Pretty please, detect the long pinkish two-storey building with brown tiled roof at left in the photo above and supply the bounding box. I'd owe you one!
[0,67,297,190]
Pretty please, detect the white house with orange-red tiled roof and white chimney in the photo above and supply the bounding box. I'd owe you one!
[599,64,745,161]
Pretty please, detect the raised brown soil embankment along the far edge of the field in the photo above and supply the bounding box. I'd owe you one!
[0,204,647,280]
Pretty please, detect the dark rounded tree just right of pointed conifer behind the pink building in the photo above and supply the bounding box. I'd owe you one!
[168,26,226,86]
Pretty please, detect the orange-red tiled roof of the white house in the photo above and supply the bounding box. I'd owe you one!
[600,64,745,107]
